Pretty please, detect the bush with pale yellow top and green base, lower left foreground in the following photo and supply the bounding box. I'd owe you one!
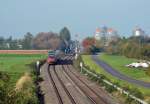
[7,73,38,104]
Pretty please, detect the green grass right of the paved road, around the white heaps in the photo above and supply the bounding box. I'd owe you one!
[100,53,150,82]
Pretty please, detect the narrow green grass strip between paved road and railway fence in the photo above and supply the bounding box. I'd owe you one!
[82,55,150,96]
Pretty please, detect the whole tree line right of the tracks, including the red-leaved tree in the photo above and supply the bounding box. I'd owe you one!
[82,36,150,60]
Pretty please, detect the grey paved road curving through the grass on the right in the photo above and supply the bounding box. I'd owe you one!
[92,55,150,88]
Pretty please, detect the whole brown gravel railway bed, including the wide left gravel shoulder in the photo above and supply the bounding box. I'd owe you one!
[40,56,117,104]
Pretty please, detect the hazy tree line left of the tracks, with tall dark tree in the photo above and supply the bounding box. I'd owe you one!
[0,27,71,50]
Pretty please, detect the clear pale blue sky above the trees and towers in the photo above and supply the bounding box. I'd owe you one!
[0,0,150,39]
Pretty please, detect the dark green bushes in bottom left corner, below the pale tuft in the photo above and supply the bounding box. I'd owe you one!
[0,68,38,104]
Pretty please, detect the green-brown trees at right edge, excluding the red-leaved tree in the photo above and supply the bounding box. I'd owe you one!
[105,36,150,60]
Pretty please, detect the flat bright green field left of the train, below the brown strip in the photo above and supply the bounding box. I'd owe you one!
[0,54,46,84]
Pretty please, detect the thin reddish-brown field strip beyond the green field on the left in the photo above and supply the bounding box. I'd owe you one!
[0,50,48,54]
